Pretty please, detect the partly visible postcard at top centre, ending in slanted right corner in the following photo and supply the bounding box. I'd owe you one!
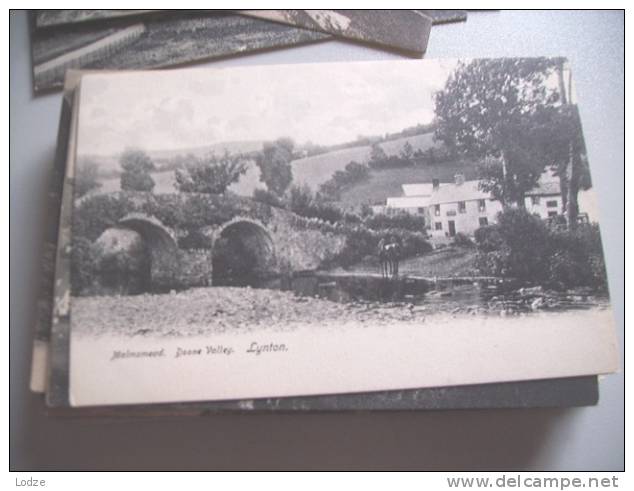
[240,10,432,57]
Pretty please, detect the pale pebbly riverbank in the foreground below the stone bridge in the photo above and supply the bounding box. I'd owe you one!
[71,286,606,336]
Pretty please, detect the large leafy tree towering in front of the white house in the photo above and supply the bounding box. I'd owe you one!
[434,58,560,207]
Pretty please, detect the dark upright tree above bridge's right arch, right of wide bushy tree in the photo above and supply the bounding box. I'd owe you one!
[255,138,295,196]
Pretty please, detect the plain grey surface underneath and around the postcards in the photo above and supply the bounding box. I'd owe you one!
[10,11,625,471]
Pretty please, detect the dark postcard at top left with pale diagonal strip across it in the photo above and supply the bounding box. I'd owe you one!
[31,11,330,92]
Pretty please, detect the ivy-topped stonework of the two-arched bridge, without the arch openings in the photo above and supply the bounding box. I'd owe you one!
[76,192,346,290]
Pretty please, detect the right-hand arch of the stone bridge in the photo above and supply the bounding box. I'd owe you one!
[212,217,276,286]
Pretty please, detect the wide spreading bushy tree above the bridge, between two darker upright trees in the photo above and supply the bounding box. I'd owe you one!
[174,151,247,194]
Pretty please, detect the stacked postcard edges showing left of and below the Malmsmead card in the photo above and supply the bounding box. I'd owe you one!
[39,71,598,418]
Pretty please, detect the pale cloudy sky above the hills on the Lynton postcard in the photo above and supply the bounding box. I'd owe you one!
[77,60,456,160]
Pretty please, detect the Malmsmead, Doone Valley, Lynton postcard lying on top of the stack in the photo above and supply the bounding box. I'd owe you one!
[70,58,618,406]
